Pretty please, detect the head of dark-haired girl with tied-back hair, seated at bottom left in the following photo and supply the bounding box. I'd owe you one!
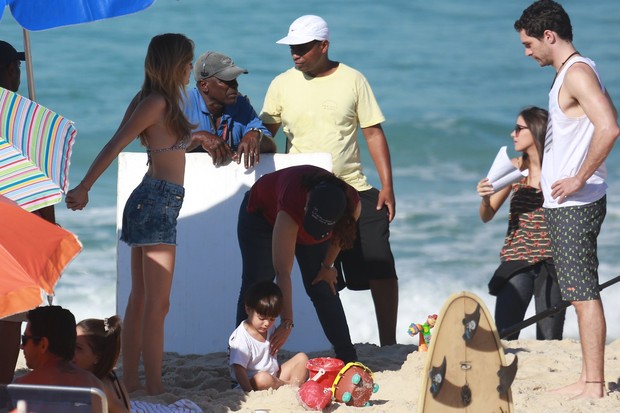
[73,316,121,379]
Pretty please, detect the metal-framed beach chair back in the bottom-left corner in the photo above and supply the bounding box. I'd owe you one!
[0,384,108,413]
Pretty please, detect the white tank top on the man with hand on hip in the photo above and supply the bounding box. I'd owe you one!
[540,56,607,208]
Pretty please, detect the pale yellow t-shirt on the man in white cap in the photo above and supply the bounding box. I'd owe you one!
[260,63,385,191]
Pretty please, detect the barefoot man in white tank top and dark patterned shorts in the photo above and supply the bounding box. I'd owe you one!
[514,0,620,398]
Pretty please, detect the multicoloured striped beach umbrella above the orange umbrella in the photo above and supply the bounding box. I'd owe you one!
[0,88,76,211]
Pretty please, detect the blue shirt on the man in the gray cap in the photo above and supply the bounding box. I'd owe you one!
[183,87,271,152]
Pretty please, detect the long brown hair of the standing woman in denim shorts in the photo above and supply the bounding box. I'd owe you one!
[140,33,194,146]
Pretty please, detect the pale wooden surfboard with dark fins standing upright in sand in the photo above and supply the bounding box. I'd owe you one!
[418,291,517,413]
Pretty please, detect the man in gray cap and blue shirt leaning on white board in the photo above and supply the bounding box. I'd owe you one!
[184,52,276,169]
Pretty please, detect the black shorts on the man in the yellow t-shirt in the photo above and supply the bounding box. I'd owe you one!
[336,188,398,290]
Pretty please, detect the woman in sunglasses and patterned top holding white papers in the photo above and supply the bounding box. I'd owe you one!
[477,107,565,340]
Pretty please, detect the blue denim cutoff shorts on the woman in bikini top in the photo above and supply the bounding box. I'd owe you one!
[121,175,185,247]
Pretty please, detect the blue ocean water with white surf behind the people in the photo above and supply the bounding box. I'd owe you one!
[0,0,620,343]
